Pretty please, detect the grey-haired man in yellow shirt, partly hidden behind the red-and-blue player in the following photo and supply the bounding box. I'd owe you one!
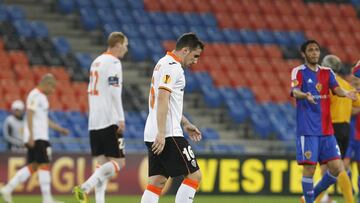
[316,55,360,203]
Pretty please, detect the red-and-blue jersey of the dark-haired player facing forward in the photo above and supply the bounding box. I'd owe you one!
[291,64,338,136]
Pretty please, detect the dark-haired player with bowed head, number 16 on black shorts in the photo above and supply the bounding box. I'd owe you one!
[141,33,204,203]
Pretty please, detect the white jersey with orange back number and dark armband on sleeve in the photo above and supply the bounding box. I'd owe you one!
[88,52,125,130]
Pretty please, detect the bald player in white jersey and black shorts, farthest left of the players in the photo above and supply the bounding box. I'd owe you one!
[0,74,69,203]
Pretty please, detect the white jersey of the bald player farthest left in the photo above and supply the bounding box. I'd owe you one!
[23,88,49,143]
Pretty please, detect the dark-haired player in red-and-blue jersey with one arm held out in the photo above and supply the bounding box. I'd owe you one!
[291,40,357,203]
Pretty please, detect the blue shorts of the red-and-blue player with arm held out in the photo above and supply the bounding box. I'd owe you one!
[296,135,341,165]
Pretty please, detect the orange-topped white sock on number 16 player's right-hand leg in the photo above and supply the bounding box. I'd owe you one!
[175,178,199,203]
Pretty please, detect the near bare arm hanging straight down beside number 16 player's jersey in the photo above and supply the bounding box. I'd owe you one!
[152,89,170,154]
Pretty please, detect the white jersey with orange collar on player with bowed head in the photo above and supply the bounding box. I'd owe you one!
[144,52,185,142]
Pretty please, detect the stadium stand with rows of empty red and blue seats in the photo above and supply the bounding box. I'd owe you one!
[0,0,360,153]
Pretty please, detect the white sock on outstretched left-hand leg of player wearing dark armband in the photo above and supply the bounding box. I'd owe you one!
[81,161,119,193]
